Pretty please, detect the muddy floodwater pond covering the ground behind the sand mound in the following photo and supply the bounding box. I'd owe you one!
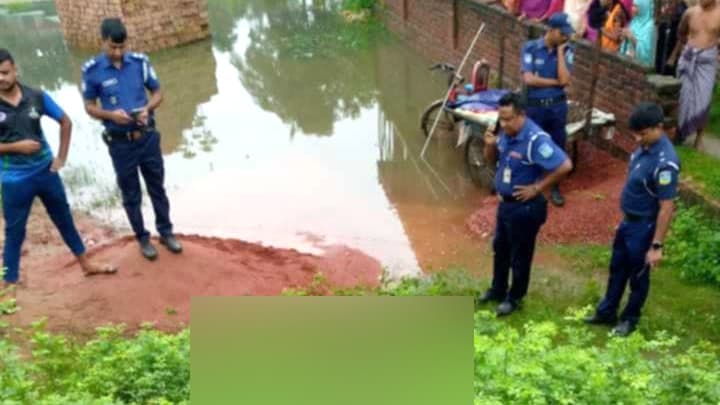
[0,0,490,274]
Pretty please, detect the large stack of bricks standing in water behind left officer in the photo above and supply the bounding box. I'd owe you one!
[55,0,210,52]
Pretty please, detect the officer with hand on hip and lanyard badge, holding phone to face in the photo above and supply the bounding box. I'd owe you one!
[477,93,572,316]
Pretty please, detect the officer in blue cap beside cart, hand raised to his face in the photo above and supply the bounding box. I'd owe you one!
[520,13,575,206]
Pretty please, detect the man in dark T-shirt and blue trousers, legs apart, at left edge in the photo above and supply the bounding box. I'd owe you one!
[0,49,117,292]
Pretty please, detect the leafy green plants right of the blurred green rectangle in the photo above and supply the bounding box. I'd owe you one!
[475,312,720,405]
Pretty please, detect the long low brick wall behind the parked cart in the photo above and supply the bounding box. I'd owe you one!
[384,0,679,151]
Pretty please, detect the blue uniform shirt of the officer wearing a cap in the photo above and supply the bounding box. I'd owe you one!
[520,37,575,99]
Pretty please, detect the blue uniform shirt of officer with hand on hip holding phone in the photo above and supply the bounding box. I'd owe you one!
[495,118,567,197]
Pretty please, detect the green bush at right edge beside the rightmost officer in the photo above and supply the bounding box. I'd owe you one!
[665,206,720,286]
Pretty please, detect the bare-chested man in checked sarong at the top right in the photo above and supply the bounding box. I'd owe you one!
[668,0,720,147]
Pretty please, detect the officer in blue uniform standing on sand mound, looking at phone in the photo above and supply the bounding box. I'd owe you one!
[82,18,182,260]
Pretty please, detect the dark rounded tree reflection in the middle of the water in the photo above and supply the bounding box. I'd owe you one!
[232,1,376,135]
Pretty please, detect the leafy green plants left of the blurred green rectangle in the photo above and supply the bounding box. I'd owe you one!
[0,322,190,405]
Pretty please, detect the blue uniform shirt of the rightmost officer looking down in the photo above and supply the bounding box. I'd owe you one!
[620,135,680,218]
